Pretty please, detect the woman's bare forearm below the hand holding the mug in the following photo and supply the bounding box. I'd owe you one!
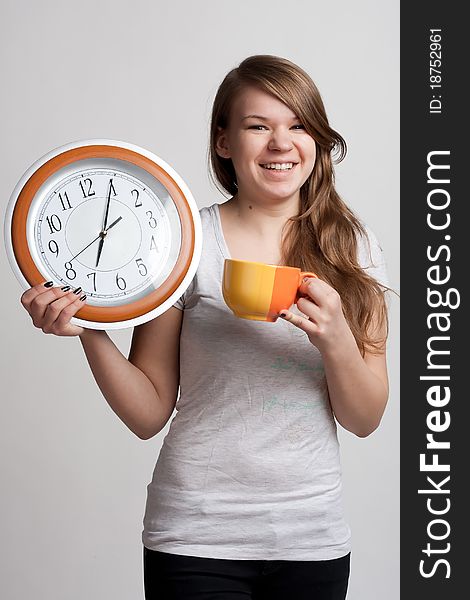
[322,333,388,437]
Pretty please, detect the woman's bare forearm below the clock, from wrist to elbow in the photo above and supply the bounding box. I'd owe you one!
[80,329,166,439]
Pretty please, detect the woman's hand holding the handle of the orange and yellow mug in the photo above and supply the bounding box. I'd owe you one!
[280,277,352,351]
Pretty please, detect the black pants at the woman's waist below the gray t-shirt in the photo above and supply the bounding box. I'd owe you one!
[144,546,350,600]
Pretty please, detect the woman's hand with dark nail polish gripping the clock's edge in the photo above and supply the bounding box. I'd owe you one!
[21,282,86,336]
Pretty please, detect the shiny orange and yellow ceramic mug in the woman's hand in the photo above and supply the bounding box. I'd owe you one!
[222,258,316,322]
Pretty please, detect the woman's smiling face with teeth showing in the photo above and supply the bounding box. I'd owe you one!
[216,87,316,202]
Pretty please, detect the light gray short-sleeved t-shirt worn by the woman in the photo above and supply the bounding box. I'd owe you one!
[142,204,387,560]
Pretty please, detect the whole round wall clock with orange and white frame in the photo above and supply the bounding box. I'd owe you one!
[5,139,202,329]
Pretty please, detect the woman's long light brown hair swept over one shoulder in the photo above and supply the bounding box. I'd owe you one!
[208,55,389,355]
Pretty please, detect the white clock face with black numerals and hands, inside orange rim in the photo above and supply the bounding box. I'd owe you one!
[27,158,181,306]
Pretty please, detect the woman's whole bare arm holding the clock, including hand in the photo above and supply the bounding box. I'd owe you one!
[21,284,183,439]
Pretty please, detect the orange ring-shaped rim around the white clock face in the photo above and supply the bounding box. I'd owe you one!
[11,144,195,323]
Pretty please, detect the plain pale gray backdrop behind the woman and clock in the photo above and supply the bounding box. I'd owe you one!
[0,0,399,600]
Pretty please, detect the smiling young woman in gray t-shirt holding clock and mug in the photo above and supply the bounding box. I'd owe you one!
[22,56,388,600]
